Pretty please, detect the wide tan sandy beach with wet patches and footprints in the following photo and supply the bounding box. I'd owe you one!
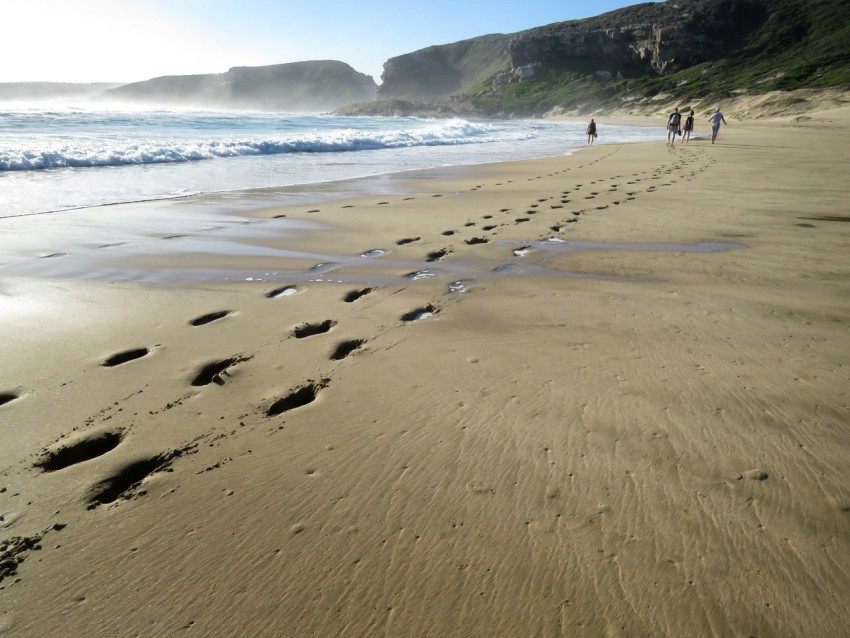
[0,109,850,638]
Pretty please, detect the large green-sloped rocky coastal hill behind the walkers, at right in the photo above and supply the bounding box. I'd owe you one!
[372,0,850,117]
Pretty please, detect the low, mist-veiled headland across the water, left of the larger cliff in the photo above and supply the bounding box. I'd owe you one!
[104,60,377,111]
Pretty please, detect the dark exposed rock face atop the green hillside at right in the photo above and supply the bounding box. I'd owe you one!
[508,0,768,75]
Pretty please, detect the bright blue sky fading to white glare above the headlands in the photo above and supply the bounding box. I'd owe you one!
[0,0,652,82]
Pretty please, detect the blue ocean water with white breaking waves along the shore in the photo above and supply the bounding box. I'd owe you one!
[0,104,659,217]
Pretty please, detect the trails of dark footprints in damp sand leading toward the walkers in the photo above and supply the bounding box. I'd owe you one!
[0,149,708,576]
